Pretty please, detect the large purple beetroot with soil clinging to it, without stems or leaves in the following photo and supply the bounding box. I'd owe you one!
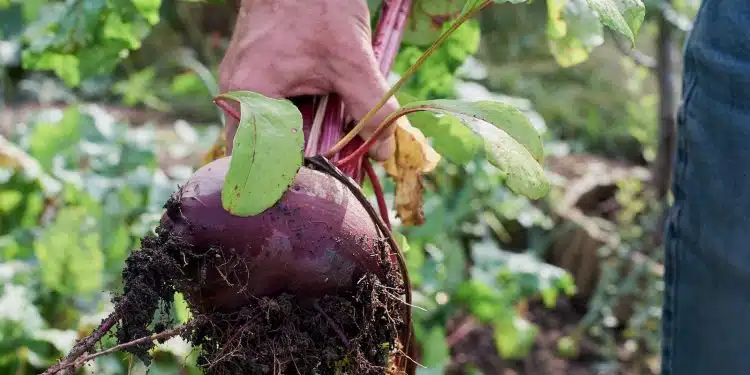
[99,157,413,375]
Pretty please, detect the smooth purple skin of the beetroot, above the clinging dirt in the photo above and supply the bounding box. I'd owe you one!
[161,157,387,310]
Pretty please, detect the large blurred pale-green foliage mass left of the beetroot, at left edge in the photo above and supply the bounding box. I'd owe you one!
[0,106,212,374]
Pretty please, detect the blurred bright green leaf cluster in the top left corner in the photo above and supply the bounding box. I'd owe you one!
[20,0,161,86]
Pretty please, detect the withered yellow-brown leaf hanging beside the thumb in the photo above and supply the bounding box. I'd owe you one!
[383,117,440,226]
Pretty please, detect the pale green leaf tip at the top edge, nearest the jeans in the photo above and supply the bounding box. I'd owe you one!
[586,0,646,43]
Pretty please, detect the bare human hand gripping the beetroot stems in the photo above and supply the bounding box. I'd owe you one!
[219,0,398,161]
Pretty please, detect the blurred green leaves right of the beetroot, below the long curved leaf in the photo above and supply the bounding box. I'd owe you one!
[397,142,575,374]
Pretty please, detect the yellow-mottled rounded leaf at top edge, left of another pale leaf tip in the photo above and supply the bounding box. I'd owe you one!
[547,0,604,67]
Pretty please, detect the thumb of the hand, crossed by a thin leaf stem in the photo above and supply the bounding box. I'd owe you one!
[334,52,399,161]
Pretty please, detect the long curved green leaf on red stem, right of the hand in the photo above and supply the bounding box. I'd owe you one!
[400,99,550,199]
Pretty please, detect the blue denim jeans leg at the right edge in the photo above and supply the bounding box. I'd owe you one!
[662,0,750,375]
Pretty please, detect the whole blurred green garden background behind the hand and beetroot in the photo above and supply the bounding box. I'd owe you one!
[0,0,698,375]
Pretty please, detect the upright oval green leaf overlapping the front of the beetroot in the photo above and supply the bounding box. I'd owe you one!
[219,91,305,216]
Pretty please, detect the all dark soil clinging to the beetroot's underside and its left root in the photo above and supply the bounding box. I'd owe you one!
[108,200,405,375]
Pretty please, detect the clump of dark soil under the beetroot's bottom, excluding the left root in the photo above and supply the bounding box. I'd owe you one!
[191,275,403,375]
